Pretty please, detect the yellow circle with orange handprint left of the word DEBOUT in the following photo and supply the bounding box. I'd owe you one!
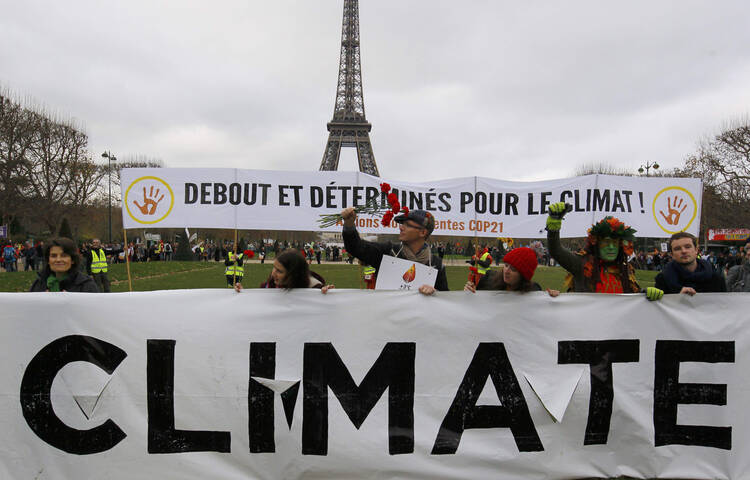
[125,177,174,225]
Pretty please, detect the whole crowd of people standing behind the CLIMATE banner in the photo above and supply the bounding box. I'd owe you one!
[0,203,750,294]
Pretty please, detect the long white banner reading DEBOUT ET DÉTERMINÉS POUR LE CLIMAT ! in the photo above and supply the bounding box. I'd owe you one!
[122,168,702,238]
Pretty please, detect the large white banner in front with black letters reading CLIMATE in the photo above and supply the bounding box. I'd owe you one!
[0,289,750,480]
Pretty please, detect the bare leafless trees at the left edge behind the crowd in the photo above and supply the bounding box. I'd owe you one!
[0,92,161,240]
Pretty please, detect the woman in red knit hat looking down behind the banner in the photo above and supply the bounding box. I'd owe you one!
[464,247,560,297]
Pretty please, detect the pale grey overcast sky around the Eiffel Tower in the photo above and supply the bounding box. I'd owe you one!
[0,0,750,182]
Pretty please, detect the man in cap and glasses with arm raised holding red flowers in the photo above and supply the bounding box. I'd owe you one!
[341,207,448,295]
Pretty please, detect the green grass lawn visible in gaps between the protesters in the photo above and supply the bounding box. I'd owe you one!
[0,262,657,292]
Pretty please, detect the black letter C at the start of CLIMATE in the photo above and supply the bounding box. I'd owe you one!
[21,335,127,455]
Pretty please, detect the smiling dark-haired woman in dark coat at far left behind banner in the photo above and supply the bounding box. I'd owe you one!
[29,237,99,293]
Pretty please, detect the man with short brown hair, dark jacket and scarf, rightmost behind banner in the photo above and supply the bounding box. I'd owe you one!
[655,232,727,295]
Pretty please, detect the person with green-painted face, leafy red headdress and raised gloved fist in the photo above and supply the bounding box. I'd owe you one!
[547,202,664,300]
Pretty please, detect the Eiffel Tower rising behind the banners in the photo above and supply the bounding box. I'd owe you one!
[320,0,380,177]
